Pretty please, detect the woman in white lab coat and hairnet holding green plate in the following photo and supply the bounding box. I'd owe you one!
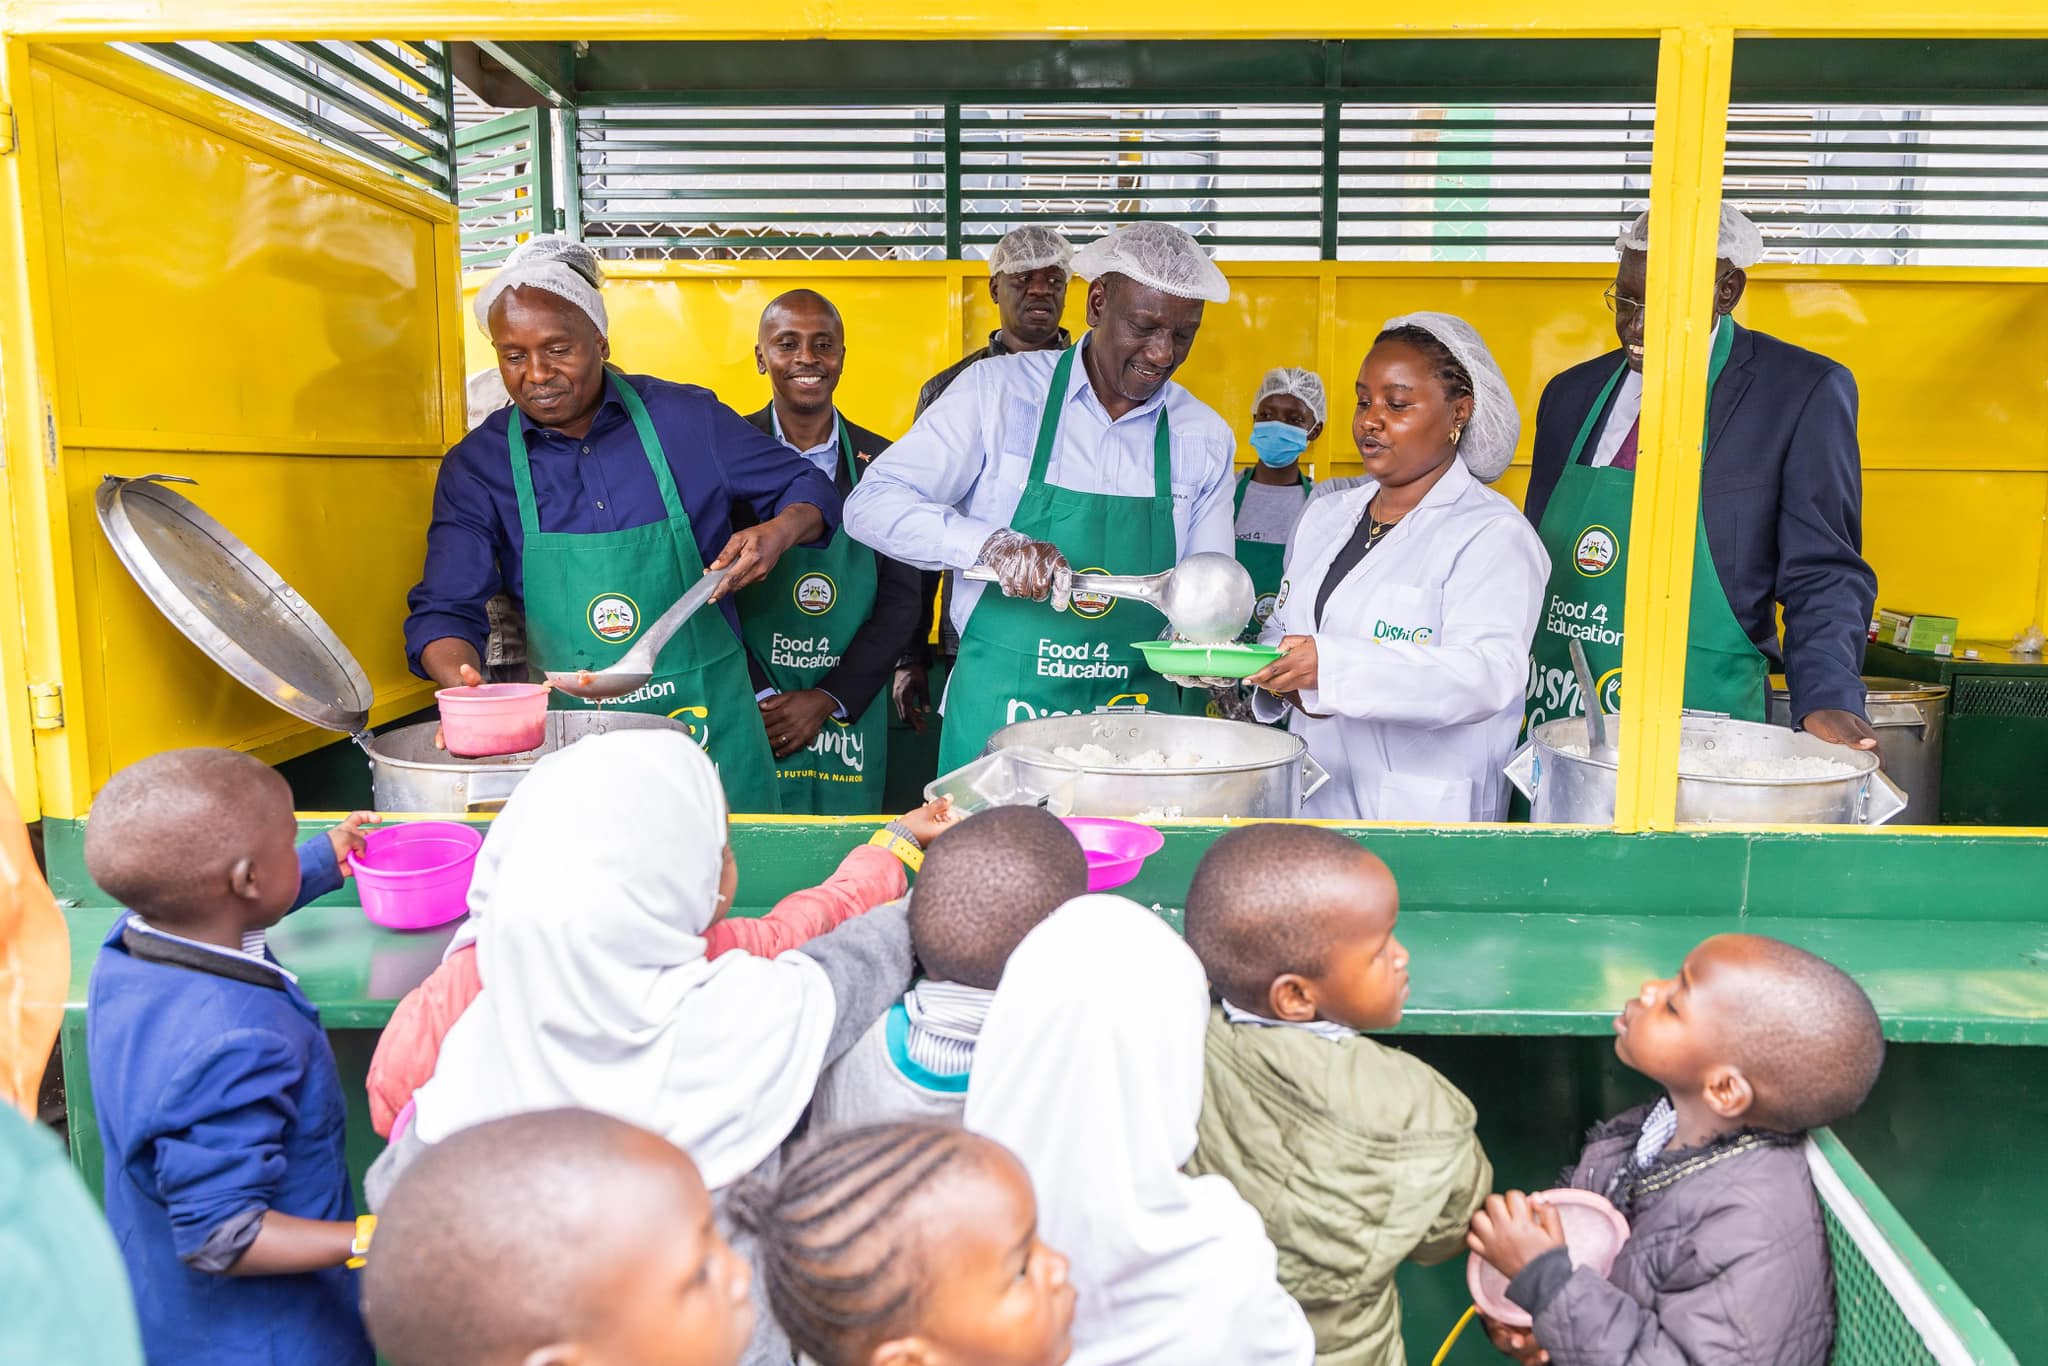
[1249,313,1550,823]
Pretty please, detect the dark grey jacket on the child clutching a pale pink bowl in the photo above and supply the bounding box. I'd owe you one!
[1507,1106,1835,1366]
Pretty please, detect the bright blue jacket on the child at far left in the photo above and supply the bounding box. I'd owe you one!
[86,836,373,1366]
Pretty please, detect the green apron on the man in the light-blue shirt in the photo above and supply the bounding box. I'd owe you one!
[938,346,1184,772]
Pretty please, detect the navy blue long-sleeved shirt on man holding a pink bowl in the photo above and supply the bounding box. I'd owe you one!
[406,373,840,678]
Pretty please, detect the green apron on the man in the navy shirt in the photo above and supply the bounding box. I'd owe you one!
[508,379,780,813]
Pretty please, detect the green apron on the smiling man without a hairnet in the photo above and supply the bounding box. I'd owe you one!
[739,418,889,815]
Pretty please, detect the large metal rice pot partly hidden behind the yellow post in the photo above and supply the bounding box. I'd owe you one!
[1507,717,1907,825]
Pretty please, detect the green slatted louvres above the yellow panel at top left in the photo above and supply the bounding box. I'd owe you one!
[123,39,455,195]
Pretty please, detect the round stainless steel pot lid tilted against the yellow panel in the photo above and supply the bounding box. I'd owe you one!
[94,475,371,735]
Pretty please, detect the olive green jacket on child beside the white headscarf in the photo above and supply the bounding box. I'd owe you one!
[1188,1010,1493,1366]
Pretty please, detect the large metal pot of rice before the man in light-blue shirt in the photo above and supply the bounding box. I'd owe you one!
[985,711,1329,819]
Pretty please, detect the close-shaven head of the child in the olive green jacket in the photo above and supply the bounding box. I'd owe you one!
[1186,821,1399,1014]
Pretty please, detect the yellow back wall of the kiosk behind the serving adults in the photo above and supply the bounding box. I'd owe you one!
[465,262,2048,655]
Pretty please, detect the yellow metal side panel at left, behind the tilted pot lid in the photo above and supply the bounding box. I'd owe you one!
[8,49,463,815]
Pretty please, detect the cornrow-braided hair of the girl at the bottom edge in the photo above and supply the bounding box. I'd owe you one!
[727,1122,977,1366]
